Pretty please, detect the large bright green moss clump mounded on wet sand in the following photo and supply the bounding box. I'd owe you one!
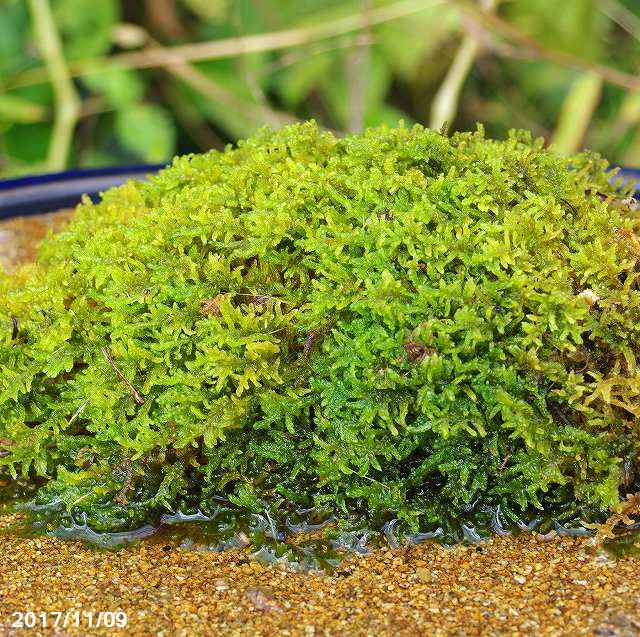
[0,124,640,530]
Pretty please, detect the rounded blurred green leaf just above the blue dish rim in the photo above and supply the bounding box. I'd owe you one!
[115,104,176,162]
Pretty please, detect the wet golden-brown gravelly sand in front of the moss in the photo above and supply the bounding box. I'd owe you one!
[0,520,640,637]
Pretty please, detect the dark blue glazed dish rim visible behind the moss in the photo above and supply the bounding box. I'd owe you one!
[0,164,640,219]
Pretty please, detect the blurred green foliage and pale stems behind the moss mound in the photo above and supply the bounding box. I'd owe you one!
[0,0,640,177]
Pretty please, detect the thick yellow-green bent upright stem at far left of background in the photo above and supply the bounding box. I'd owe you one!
[29,0,80,171]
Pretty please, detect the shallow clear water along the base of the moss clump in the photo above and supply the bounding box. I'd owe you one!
[0,481,640,571]
